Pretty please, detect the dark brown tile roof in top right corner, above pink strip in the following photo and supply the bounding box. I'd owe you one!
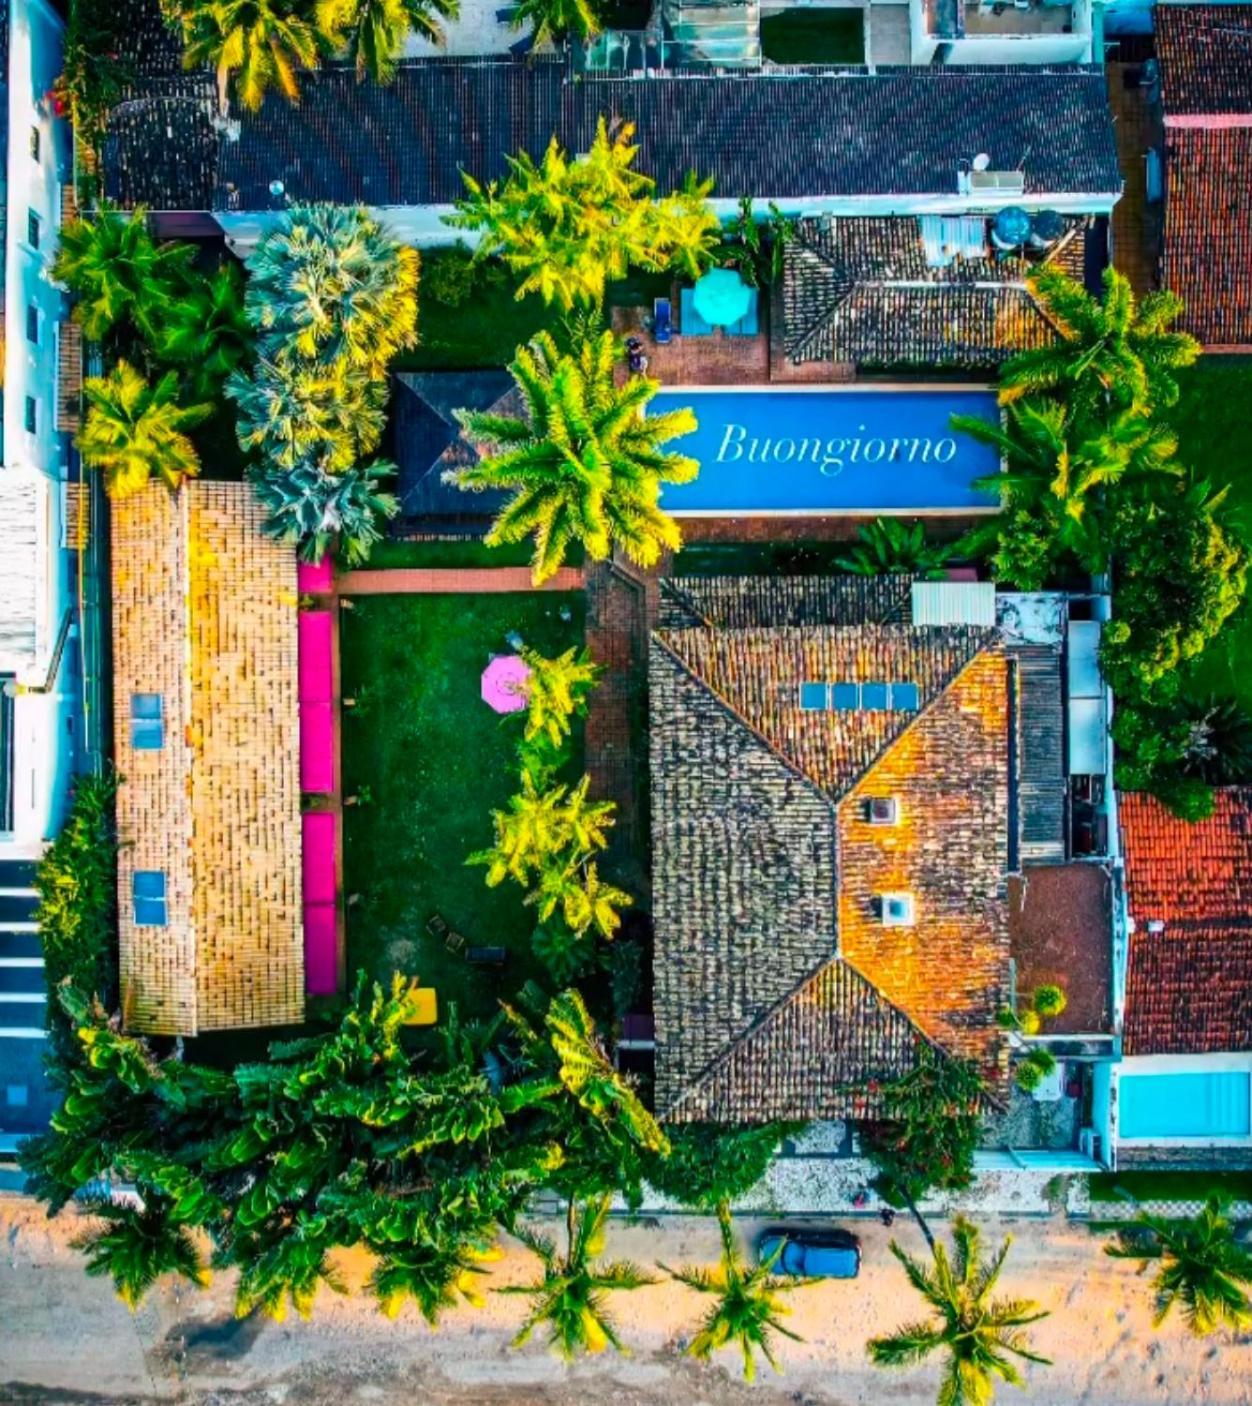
[1155,4,1252,117]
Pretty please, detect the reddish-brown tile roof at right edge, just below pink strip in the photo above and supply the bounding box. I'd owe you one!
[1163,126,1252,347]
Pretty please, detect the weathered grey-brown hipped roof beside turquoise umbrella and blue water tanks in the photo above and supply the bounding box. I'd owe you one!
[782,215,1096,368]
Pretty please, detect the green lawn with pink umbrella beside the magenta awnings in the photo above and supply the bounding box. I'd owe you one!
[340,592,582,1015]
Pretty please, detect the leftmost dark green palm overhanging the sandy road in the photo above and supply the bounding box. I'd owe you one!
[75,1195,210,1312]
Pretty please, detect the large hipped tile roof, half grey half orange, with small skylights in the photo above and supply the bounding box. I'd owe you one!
[649,578,1009,1122]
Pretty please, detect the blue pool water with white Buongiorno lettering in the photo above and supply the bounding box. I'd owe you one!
[653,387,1000,516]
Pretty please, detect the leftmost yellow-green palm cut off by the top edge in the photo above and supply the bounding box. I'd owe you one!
[167,0,331,112]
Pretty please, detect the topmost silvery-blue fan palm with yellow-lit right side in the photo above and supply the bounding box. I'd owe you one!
[246,205,418,378]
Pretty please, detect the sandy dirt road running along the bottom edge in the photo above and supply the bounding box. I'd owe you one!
[0,1198,1252,1406]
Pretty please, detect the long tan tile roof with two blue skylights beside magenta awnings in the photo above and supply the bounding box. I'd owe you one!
[111,482,304,1035]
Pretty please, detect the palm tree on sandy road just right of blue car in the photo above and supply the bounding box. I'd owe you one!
[869,1216,1048,1406]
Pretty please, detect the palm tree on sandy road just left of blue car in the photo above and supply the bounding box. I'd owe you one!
[661,1201,816,1382]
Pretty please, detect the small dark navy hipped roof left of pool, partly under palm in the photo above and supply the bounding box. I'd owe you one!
[391,370,509,519]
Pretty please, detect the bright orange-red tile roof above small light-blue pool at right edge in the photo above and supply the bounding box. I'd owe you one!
[1118,786,1252,1055]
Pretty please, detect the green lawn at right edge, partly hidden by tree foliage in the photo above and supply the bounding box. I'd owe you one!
[1169,356,1252,710]
